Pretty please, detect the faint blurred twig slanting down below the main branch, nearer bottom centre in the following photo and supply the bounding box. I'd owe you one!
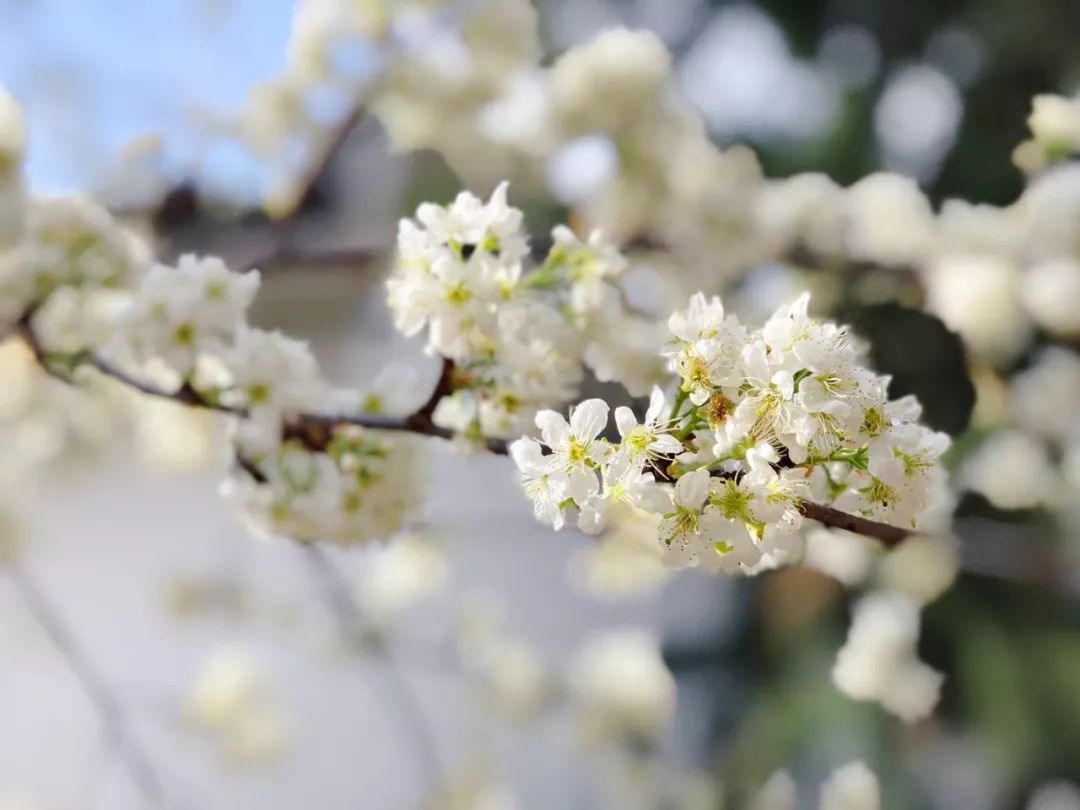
[305,545,442,792]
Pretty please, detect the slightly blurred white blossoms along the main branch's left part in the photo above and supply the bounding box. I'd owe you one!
[0,91,429,543]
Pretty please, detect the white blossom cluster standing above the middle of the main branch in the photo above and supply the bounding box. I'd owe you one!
[388,184,648,436]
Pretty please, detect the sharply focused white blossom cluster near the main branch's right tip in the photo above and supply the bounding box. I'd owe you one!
[511,294,948,572]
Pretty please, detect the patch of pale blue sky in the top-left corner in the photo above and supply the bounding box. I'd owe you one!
[0,0,293,191]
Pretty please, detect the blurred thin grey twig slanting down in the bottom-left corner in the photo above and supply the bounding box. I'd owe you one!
[4,561,165,807]
